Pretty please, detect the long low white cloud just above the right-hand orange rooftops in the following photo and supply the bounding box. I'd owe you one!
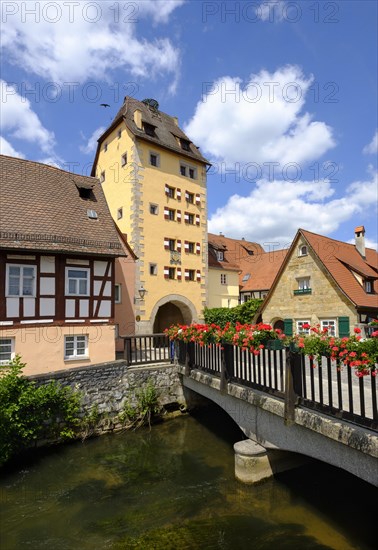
[209,169,377,247]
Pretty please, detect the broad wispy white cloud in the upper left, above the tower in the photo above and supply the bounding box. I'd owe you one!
[2,0,182,90]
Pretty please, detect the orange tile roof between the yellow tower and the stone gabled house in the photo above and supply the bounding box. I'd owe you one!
[240,249,288,292]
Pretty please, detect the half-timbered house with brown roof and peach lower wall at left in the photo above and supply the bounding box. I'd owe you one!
[0,155,126,374]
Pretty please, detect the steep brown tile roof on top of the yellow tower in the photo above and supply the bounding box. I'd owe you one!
[94,96,210,165]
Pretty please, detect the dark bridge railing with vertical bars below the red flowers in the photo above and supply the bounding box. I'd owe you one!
[176,341,378,430]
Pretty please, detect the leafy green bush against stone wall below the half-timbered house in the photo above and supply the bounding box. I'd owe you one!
[0,356,80,466]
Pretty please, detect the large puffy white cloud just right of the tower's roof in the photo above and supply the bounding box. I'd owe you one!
[185,65,335,169]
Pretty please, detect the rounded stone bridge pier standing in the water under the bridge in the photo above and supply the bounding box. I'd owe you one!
[234,439,310,484]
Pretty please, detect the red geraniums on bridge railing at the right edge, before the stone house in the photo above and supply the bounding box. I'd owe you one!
[293,325,378,377]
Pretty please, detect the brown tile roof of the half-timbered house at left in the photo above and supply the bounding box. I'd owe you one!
[0,155,124,256]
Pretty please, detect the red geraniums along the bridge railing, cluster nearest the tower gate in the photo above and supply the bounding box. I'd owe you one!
[165,323,285,355]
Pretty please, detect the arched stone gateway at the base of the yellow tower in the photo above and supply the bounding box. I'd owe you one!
[151,294,198,334]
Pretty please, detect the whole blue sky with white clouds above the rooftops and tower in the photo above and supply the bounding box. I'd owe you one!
[0,0,378,250]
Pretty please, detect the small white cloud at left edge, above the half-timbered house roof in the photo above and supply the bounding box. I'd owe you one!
[0,80,55,153]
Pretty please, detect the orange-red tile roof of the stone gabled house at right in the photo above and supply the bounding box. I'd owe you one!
[302,229,378,308]
